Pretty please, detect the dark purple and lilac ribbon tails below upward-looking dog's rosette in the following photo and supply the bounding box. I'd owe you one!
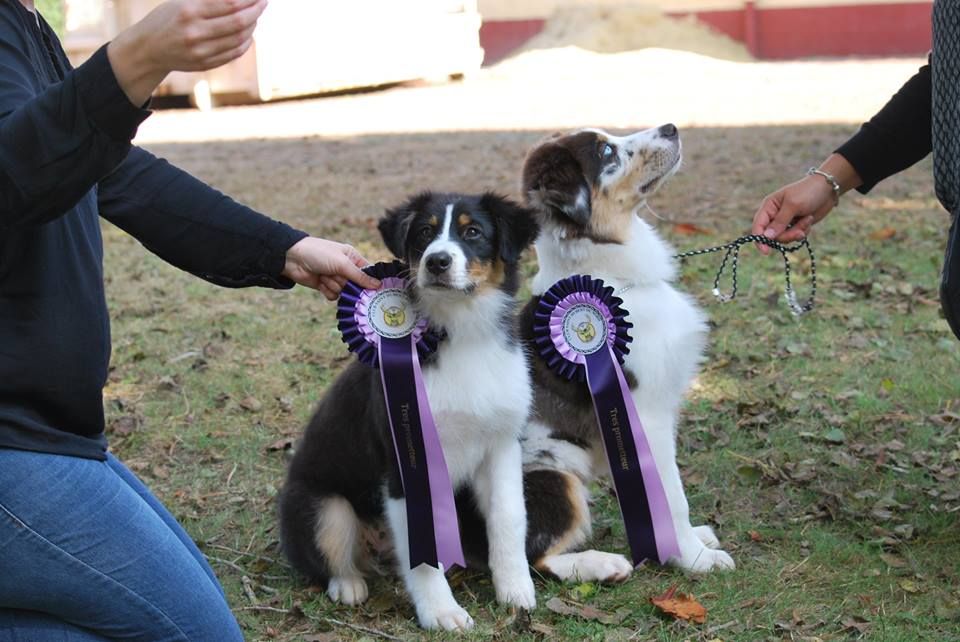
[585,345,680,565]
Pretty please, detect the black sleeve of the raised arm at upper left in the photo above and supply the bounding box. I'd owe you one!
[0,2,149,231]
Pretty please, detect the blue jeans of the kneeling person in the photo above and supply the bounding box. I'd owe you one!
[0,449,243,642]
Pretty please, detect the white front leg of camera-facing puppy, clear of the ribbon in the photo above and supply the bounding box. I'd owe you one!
[474,437,537,609]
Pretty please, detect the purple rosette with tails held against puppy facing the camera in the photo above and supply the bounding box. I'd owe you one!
[337,261,466,570]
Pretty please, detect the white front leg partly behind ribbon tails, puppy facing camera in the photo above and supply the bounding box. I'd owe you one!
[385,497,473,631]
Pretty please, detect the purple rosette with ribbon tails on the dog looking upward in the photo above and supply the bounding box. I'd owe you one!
[534,275,680,565]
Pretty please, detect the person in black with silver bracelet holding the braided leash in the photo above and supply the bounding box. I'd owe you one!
[752,0,960,339]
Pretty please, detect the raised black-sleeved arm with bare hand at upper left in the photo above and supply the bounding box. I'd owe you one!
[0,0,266,232]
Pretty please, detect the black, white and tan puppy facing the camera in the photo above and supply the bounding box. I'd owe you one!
[280,192,538,630]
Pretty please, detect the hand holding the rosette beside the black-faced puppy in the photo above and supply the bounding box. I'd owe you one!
[283,236,380,301]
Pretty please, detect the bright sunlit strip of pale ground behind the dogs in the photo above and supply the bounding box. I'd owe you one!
[138,47,922,144]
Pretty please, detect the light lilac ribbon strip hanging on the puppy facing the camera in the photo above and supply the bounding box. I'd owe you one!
[410,335,467,571]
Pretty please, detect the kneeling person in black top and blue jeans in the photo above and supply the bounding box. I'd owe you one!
[0,0,378,642]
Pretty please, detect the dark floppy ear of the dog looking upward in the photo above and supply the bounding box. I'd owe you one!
[523,142,592,225]
